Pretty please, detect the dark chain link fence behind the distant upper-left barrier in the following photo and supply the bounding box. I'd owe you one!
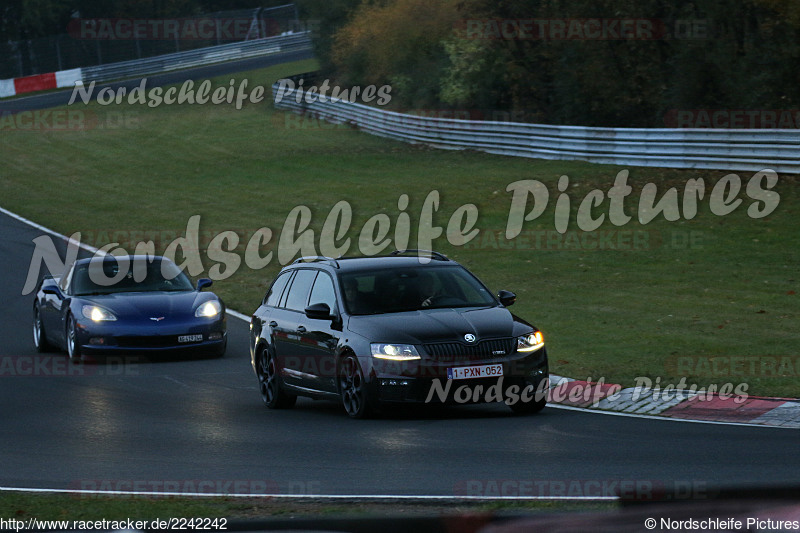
[0,4,306,79]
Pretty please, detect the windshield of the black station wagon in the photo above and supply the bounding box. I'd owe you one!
[341,266,497,315]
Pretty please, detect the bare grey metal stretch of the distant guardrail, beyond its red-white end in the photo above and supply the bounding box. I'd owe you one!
[83,32,311,83]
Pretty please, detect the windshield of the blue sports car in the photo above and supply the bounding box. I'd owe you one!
[73,260,194,296]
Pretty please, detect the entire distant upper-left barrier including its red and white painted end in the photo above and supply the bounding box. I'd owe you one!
[0,32,311,98]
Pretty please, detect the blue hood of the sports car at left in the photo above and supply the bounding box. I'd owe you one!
[81,291,209,318]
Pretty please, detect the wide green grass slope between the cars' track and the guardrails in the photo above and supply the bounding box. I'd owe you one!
[0,61,800,397]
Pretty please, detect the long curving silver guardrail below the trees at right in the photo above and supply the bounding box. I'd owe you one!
[272,80,800,174]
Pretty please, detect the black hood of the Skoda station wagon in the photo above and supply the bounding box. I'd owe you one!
[349,307,519,344]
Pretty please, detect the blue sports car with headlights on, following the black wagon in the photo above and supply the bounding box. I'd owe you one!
[33,255,227,361]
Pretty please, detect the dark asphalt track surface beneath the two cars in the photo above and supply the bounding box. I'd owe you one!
[0,209,800,496]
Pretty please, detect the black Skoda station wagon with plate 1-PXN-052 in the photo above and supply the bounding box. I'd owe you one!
[250,250,548,418]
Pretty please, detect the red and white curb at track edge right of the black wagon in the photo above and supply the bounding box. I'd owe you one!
[549,374,800,428]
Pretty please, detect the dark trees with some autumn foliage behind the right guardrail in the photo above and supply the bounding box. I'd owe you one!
[298,0,800,127]
